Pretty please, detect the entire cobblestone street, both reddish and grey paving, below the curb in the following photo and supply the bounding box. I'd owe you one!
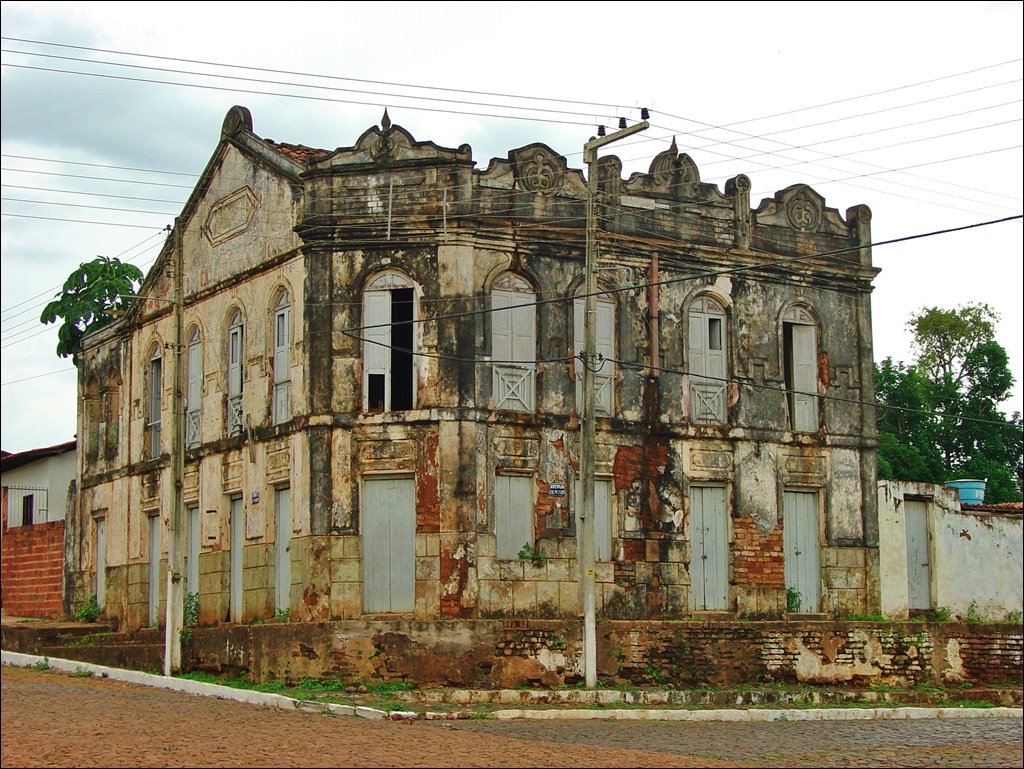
[2,667,1024,767]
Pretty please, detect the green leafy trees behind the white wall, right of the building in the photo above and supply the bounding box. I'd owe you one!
[876,304,1024,503]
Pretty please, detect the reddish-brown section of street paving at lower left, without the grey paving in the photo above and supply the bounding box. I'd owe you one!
[0,667,727,767]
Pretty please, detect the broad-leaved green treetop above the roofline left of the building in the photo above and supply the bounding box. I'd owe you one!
[39,256,142,366]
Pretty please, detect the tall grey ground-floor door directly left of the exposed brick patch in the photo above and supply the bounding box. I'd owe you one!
[690,486,729,611]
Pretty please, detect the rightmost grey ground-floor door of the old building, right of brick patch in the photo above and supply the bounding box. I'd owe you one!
[782,492,821,611]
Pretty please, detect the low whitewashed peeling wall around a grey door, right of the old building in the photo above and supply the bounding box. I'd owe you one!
[879,481,1024,620]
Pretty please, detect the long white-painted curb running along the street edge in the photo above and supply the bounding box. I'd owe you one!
[6,651,1024,722]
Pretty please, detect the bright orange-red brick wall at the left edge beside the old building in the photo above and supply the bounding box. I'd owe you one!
[0,520,65,618]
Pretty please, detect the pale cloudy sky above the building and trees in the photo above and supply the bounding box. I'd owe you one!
[0,2,1024,452]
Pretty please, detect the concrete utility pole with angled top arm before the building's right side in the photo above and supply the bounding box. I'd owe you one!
[577,120,650,689]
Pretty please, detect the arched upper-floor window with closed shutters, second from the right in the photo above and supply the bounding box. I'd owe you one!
[687,296,728,423]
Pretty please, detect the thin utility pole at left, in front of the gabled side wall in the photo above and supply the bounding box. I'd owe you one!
[164,216,185,676]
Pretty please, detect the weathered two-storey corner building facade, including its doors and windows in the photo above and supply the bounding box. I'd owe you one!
[68,108,880,628]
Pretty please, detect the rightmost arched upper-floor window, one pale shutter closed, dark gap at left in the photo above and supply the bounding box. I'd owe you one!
[782,307,818,432]
